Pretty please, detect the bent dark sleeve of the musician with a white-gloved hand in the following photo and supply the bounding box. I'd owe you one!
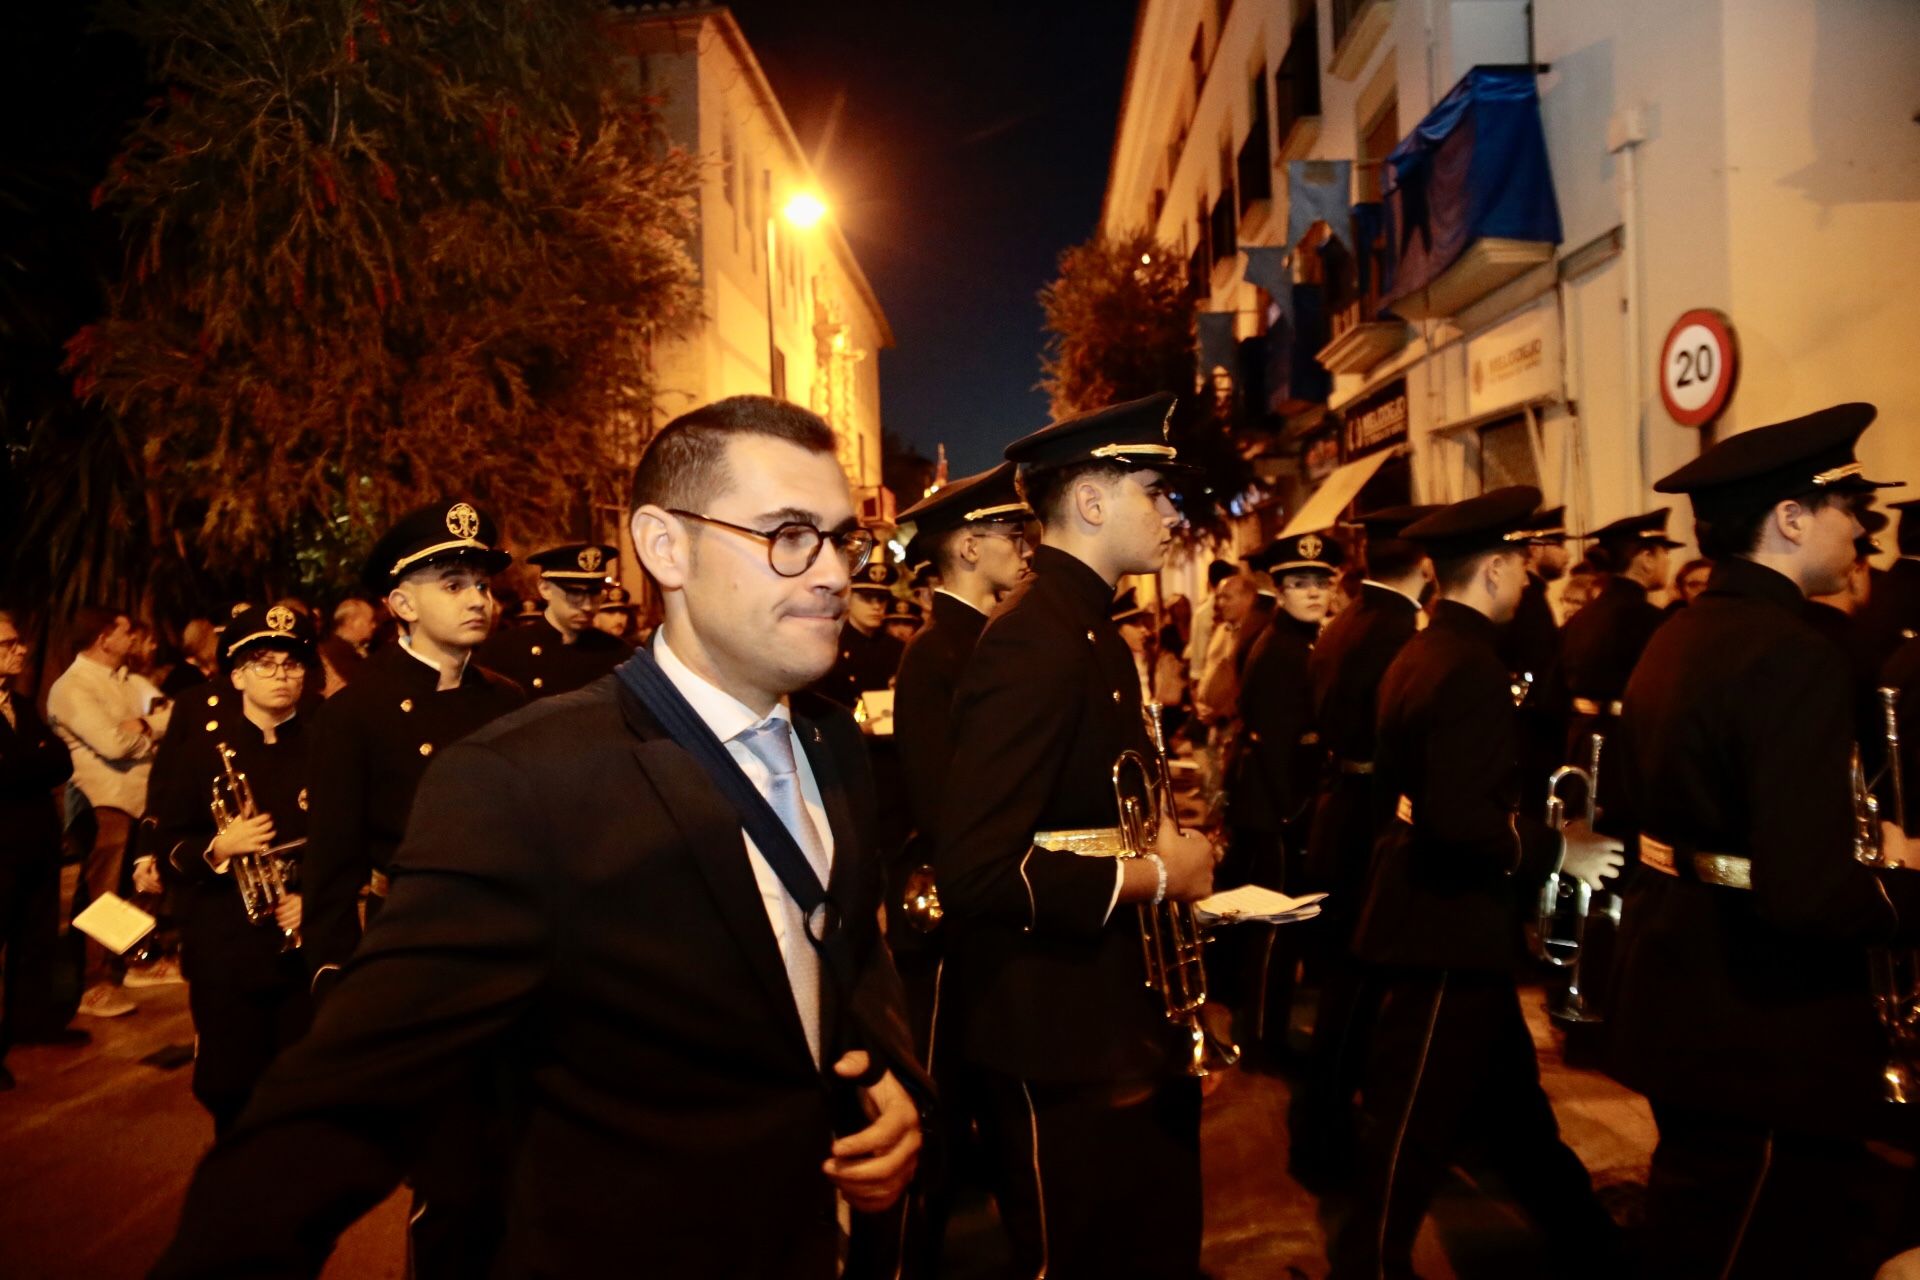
[1409,666,1561,881]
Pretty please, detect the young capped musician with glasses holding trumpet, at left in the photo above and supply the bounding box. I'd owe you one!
[150,604,319,1136]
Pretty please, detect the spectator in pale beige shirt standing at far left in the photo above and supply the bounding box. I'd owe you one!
[46,604,161,1017]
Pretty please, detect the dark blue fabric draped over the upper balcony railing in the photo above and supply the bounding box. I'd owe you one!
[1382,67,1561,314]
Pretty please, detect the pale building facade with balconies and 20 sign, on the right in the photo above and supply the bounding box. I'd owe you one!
[1102,0,1920,575]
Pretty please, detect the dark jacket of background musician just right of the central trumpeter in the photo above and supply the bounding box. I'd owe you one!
[1227,610,1325,835]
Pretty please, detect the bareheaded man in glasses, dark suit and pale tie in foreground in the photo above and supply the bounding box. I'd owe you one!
[156,395,924,1280]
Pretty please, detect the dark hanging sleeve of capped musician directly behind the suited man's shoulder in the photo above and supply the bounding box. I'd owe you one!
[300,695,372,977]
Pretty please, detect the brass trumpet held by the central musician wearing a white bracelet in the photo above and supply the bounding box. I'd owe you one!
[1114,702,1240,1077]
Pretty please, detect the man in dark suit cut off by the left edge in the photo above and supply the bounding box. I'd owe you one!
[0,612,88,1090]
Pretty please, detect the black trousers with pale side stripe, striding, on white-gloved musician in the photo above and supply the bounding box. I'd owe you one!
[1329,969,1626,1280]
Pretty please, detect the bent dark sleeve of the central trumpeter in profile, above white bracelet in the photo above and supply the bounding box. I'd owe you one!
[935,614,1116,938]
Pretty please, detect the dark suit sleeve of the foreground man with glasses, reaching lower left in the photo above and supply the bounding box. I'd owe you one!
[154,745,553,1280]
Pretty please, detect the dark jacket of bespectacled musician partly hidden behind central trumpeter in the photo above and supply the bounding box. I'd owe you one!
[887,591,987,924]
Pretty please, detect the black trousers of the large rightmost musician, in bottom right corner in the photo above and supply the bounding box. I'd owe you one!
[1634,1100,1920,1280]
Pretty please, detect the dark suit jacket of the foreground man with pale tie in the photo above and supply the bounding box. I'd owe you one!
[156,677,927,1280]
